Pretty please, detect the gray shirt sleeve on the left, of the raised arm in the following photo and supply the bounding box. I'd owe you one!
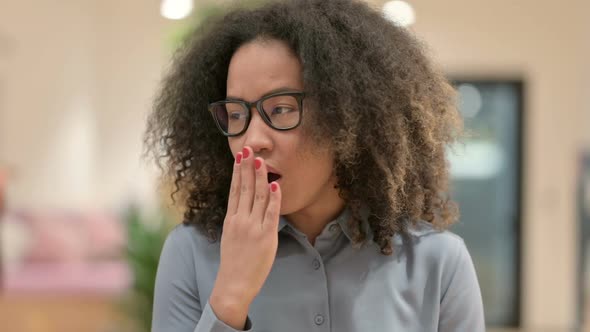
[152,225,252,332]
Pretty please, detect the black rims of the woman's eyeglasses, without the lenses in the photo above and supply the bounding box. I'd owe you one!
[209,91,305,137]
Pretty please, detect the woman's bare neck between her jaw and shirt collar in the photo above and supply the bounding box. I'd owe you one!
[285,179,346,245]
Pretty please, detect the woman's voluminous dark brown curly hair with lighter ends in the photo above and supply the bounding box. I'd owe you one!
[145,0,462,255]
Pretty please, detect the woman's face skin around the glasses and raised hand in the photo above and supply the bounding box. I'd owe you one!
[227,40,338,215]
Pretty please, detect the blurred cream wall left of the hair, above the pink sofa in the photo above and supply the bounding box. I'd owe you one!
[0,0,168,209]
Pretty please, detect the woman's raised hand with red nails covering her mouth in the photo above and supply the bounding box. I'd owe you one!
[210,147,281,329]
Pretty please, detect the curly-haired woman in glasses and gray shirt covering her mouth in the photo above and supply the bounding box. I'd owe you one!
[146,0,484,332]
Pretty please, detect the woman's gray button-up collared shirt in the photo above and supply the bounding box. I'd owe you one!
[152,209,485,332]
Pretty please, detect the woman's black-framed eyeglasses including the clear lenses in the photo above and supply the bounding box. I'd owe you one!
[209,91,305,137]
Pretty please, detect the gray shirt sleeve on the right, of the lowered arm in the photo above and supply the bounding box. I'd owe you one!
[438,239,485,332]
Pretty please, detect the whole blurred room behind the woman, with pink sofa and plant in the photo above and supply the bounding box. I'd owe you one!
[0,0,590,332]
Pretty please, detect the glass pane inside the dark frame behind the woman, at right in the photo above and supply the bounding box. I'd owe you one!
[448,80,523,326]
